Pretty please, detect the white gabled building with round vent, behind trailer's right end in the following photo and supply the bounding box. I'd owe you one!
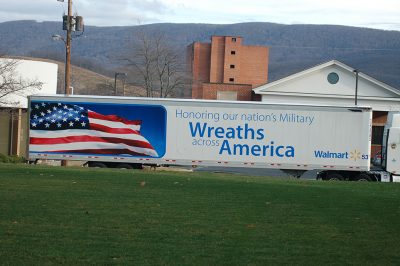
[253,60,400,156]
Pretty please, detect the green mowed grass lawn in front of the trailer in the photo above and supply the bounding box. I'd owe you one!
[0,164,400,265]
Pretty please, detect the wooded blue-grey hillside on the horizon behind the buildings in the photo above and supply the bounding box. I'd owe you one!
[0,21,400,89]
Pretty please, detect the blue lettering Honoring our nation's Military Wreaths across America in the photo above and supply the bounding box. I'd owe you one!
[175,109,315,158]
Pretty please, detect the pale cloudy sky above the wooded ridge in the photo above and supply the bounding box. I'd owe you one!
[0,0,400,31]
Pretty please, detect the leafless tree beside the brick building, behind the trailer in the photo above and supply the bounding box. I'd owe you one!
[125,32,185,98]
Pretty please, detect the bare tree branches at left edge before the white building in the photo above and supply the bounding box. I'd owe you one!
[0,56,43,104]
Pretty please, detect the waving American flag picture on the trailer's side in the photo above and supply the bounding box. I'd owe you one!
[29,102,158,157]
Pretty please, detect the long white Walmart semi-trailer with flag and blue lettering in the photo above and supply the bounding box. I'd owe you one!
[28,95,400,181]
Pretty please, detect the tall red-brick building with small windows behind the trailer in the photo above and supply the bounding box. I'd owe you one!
[187,36,269,101]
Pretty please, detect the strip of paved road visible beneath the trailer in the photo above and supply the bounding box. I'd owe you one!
[194,166,317,180]
